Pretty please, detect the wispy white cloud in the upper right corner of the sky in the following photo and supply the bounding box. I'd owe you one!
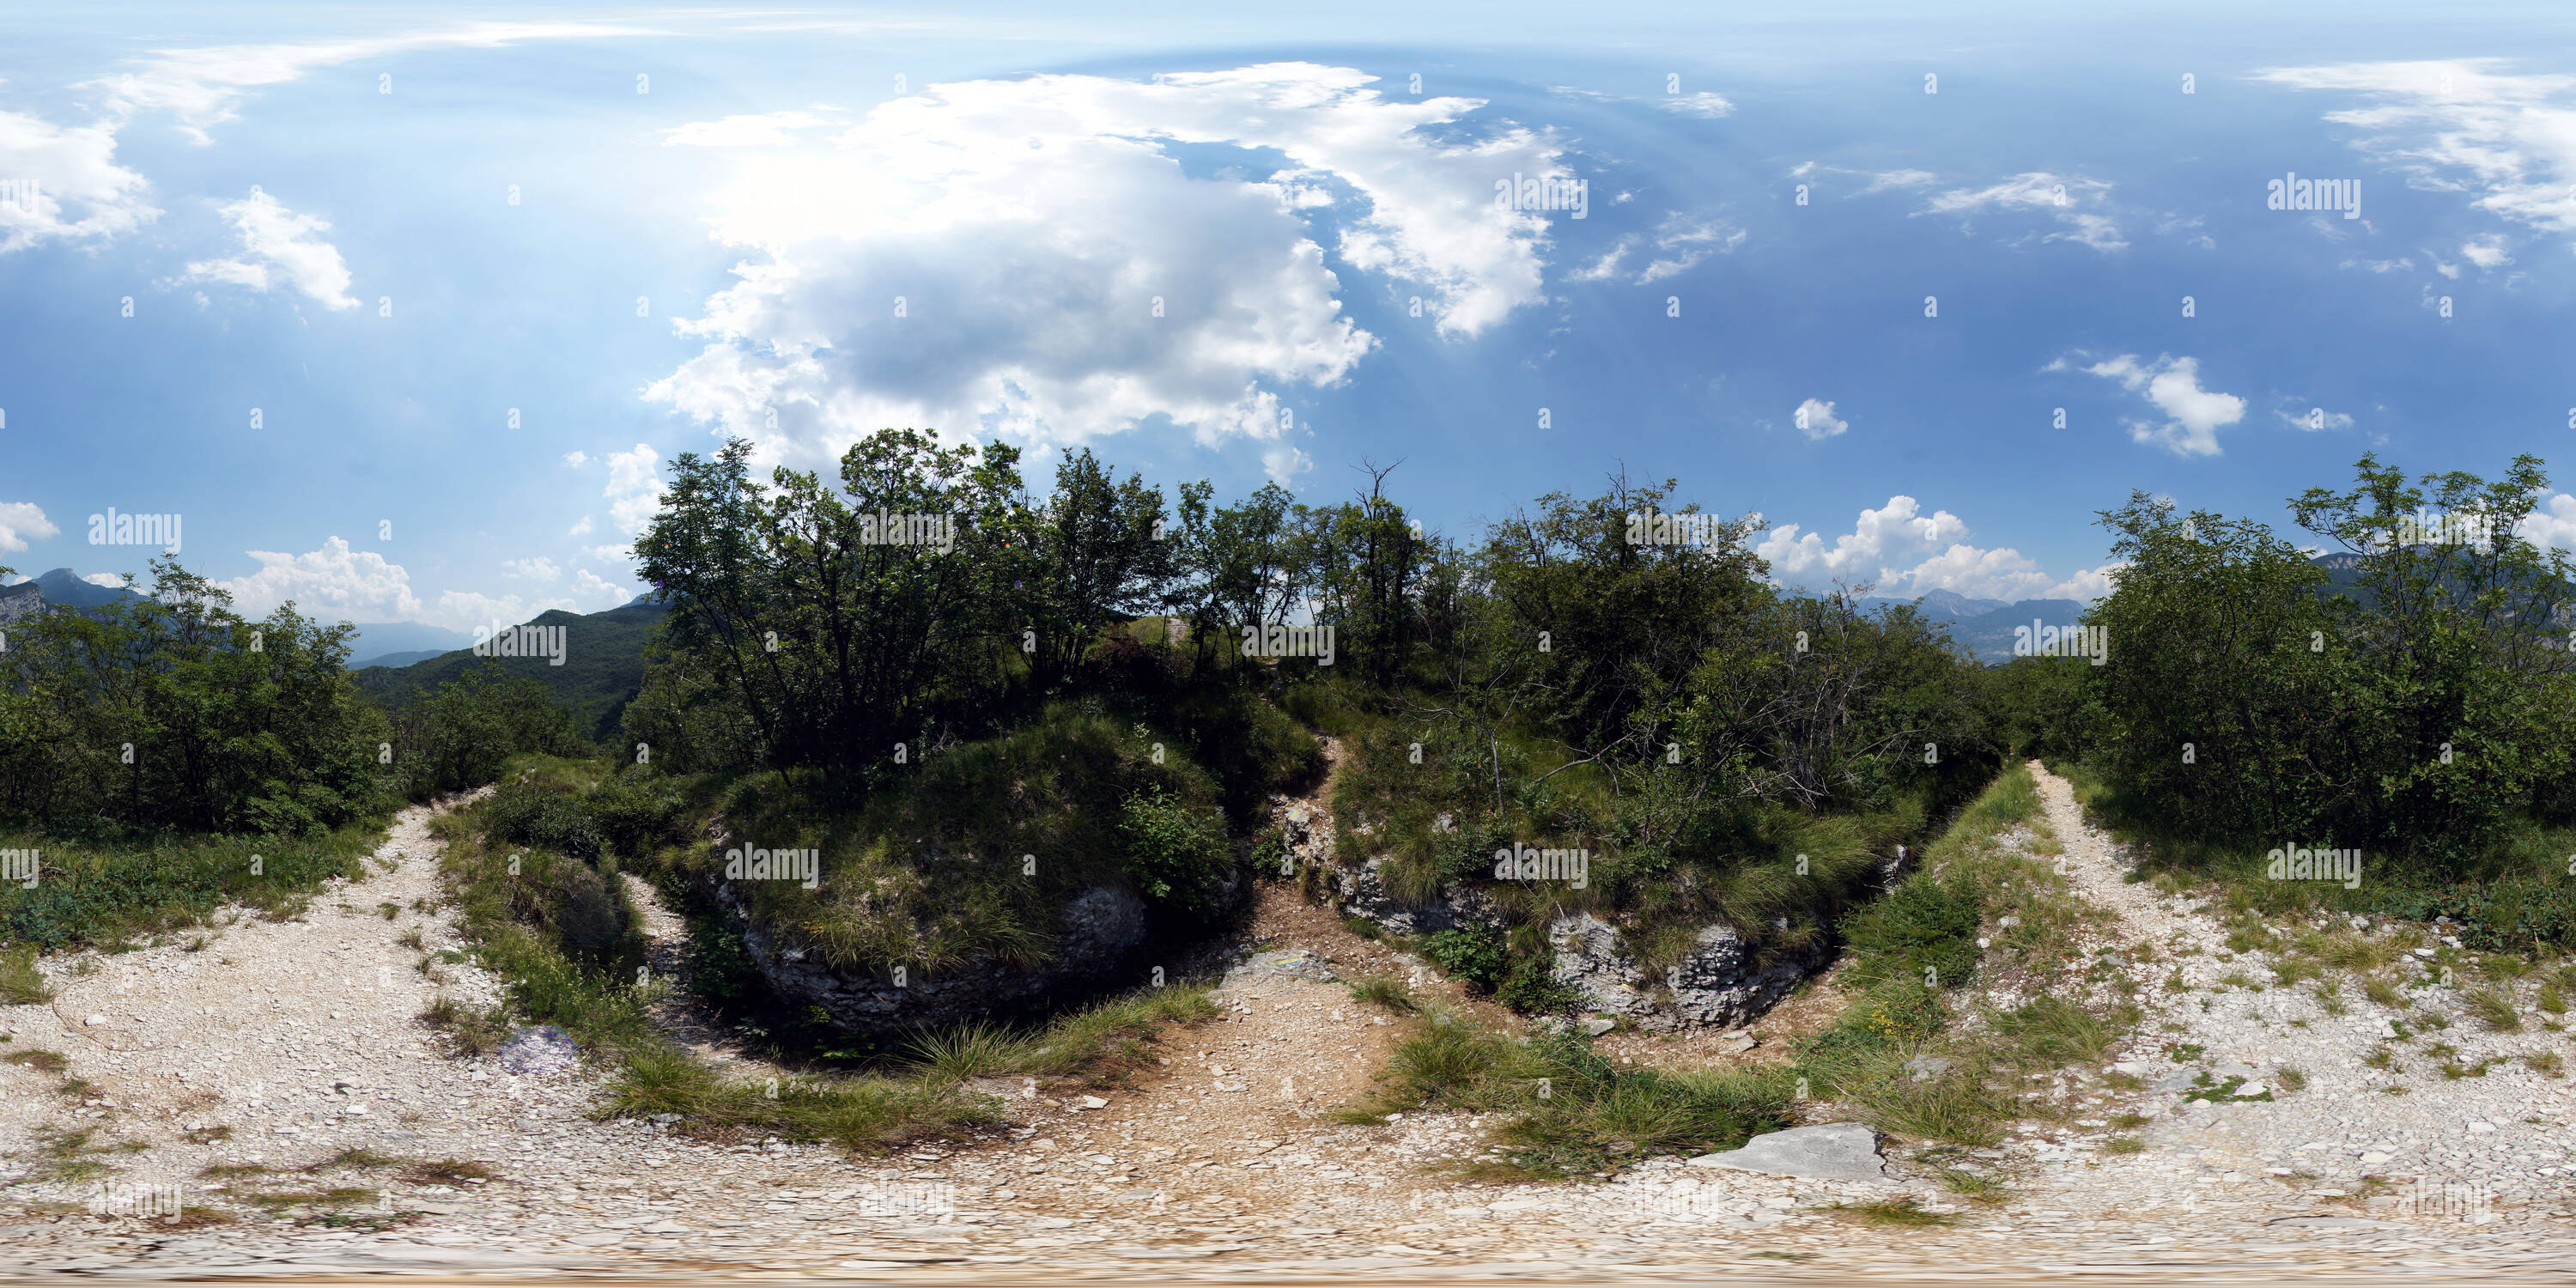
[2257,59,2576,232]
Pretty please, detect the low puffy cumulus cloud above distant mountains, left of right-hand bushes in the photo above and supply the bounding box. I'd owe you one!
[1754,497,2117,600]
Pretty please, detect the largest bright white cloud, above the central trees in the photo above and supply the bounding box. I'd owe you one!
[647,62,1571,459]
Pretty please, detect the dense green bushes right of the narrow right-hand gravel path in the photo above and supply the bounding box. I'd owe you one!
[1996,456,2576,935]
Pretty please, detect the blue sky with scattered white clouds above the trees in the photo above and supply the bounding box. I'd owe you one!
[0,3,2576,631]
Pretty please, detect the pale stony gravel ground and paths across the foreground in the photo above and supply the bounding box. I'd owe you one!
[0,773,2576,1280]
